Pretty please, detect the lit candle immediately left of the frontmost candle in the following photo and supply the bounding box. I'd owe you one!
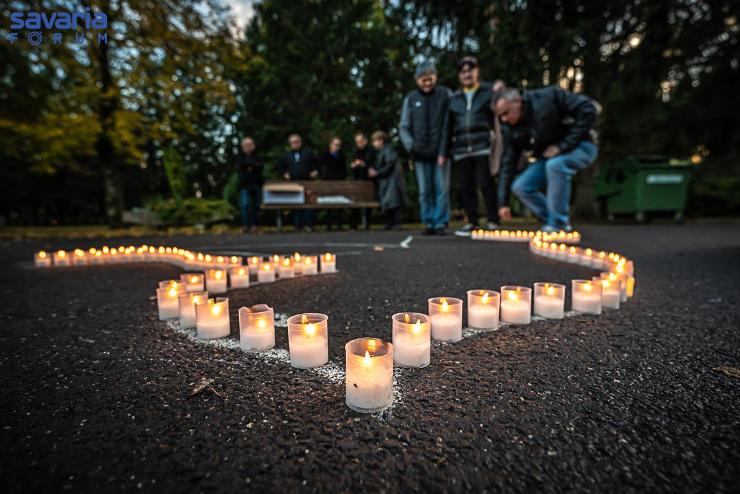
[288,313,329,369]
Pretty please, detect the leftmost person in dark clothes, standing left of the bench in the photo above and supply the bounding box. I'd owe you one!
[236,136,263,233]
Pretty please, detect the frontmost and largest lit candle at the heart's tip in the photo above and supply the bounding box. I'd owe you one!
[344,338,393,413]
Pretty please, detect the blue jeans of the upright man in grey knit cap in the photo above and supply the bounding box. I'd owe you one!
[414,161,450,228]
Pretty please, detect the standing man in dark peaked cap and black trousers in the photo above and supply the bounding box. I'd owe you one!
[438,56,499,236]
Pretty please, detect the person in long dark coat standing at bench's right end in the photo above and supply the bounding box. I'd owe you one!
[368,130,405,230]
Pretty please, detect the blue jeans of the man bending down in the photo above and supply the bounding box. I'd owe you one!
[511,141,599,228]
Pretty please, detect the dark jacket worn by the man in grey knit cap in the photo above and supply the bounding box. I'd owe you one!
[398,86,450,161]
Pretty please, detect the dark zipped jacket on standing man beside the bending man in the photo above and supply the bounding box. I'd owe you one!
[440,82,493,157]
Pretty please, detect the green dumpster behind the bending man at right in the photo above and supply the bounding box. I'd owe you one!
[594,156,691,221]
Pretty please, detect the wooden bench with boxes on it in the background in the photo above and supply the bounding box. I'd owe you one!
[260,180,380,229]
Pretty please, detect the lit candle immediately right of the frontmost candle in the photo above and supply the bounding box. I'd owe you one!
[392,312,432,367]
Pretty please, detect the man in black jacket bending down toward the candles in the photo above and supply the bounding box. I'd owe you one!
[495,86,598,231]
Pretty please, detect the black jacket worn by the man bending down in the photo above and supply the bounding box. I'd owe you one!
[498,86,598,205]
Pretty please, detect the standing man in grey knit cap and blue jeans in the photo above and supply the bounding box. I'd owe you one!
[399,61,450,235]
